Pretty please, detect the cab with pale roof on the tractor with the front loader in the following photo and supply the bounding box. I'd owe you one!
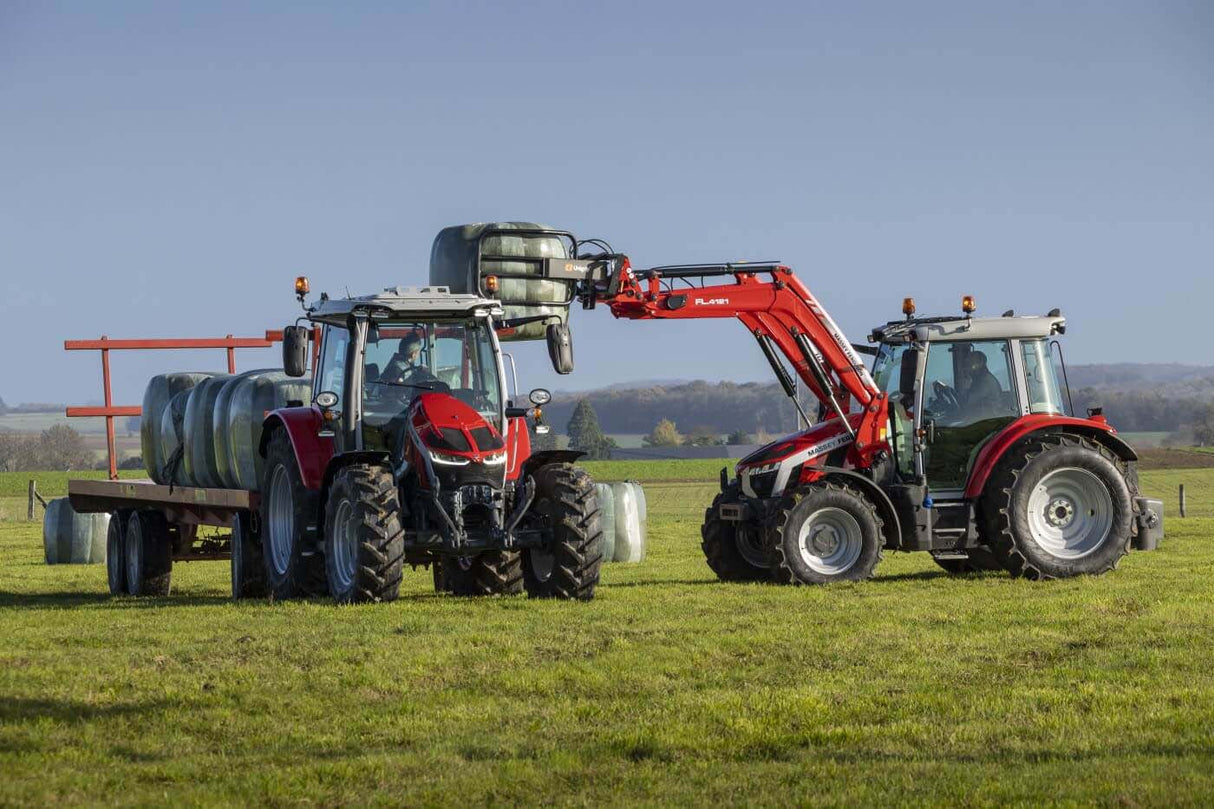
[870,299,1067,497]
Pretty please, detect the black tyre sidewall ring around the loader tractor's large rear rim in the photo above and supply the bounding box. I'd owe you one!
[1008,445,1134,578]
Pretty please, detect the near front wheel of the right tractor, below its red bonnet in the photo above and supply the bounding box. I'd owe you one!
[770,483,883,584]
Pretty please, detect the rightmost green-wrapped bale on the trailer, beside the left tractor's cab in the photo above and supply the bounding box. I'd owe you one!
[215,370,312,492]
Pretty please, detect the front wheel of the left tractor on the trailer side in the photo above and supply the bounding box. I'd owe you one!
[324,464,404,604]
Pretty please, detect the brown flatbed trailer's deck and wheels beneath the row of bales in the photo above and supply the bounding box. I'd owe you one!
[68,480,260,595]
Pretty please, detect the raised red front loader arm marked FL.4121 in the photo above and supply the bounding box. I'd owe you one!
[580,256,886,456]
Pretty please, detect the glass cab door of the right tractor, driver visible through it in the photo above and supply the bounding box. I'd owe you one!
[923,340,1021,492]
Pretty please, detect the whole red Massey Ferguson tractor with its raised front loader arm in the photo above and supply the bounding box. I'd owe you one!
[568,250,1163,584]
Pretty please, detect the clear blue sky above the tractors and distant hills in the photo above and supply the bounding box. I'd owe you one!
[0,0,1214,403]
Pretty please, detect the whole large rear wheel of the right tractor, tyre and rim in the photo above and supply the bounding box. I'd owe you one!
[982,435,1134,579]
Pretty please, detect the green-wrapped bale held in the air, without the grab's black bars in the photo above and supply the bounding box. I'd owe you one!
[430,222,573,340]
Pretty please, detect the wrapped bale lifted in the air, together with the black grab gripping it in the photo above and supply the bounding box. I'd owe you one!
[430,222,585,341]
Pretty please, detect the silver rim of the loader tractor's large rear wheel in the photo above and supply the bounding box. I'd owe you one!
[1028,469,1113,559]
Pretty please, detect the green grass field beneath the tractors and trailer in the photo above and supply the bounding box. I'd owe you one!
[0,462,1214,805]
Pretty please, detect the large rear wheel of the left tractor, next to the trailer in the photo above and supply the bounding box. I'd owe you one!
[261,429,325,599]
